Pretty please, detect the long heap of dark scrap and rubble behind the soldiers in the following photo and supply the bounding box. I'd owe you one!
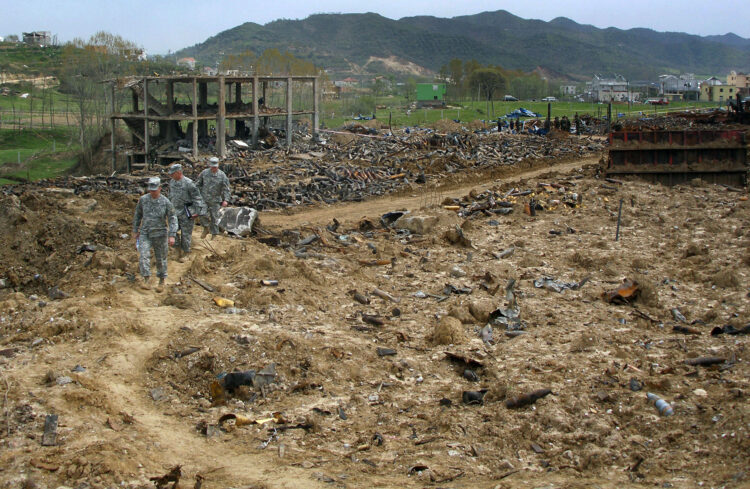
[3,130,604,210]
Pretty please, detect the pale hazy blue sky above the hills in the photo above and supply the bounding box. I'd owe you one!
[5,0,750,54]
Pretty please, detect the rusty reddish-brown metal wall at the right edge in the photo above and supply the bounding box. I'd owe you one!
[606,130,748,186]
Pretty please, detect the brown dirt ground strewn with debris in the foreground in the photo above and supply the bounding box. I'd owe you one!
[0,151,750,489]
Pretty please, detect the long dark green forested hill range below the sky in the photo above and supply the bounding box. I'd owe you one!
[175,10,750,78]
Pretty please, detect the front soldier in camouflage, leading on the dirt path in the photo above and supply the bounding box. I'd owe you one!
[133,178,177,292]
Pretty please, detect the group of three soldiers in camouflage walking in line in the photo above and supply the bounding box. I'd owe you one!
[133,158,231,292]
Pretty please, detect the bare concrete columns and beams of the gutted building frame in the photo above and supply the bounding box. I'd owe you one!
[109,75,320,171]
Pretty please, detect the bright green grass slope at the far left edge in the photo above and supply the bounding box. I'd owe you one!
[0,128,79,185]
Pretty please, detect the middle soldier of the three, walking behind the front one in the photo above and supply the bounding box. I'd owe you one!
[169,163,206,263]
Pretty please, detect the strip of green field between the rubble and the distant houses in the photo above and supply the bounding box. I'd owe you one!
[321,97,717,127]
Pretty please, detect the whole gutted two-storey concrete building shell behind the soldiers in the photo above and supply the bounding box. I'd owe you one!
[109,75,320,171]
